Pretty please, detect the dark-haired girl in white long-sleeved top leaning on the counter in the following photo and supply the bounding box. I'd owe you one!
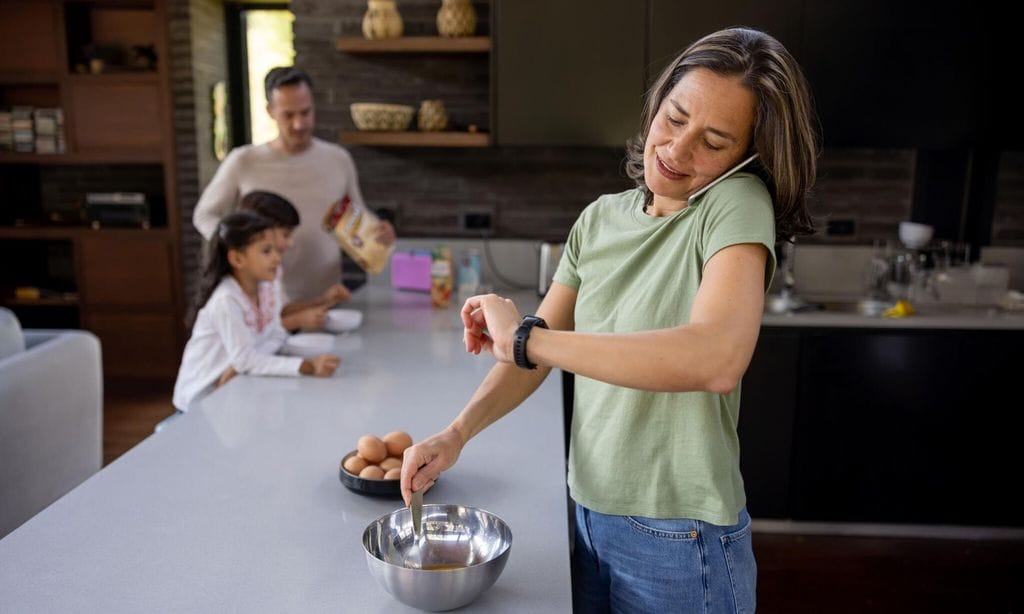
[173,212,340,411]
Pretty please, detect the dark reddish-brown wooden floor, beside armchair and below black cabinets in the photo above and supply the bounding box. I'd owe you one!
[103,382,1024,614]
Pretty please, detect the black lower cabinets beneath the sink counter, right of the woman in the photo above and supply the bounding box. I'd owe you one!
[739,327,1024,526]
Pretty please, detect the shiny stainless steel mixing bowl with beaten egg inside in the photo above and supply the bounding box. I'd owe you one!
[362,505,512,612]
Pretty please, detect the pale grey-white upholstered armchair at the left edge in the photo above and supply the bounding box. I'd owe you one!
[0,307,103,538]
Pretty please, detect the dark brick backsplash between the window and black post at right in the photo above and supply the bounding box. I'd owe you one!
[291,0,914,244]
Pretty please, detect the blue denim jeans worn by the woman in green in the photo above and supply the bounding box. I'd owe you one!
[572,503,758,614]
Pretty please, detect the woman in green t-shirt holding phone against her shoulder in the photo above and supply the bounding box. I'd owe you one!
[401,29,817,612]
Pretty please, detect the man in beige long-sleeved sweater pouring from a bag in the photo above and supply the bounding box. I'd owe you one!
[193,67,395,302]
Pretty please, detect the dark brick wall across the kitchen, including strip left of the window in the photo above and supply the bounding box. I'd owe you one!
[171,0,1024,274]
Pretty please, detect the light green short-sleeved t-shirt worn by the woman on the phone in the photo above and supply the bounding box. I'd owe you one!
[554,173,775,525]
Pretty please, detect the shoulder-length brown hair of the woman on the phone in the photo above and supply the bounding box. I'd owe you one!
[626,28,819,238]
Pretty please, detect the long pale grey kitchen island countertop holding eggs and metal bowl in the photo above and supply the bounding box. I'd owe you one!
[0,287,571,613]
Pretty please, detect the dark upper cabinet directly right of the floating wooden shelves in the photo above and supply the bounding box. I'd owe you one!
[493,0,644,147]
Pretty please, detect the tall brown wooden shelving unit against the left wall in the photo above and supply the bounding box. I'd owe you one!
[0,0,184,378]
